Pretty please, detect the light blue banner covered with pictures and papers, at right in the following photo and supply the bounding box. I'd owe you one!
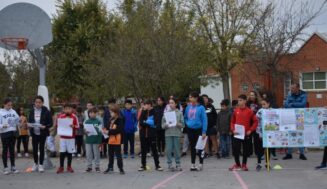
[261,108,327,148]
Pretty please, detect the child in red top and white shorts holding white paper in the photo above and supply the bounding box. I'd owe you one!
[56,104,79,174]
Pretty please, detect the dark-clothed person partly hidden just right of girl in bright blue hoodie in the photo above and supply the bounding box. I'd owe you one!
[202,94,220,158]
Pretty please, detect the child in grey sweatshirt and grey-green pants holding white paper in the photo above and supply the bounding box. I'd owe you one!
[161,98,184,171]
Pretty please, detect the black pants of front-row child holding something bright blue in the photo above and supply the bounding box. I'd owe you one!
[140,136,160,167]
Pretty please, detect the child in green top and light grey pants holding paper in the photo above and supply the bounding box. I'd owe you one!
[84,108,102,173]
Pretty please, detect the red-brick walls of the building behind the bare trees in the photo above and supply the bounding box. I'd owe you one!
[231,34,327,107]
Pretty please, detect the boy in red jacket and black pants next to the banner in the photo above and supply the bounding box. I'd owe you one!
[229,94,258,171]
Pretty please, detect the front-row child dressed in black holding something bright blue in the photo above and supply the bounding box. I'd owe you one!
[139,100,163,171]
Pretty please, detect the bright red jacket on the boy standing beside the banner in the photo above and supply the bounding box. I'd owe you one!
[230,107,258,132]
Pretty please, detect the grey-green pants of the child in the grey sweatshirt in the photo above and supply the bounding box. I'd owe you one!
[165,136,181,165]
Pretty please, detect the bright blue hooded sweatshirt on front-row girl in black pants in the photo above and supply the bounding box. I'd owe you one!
[184,104,208,134]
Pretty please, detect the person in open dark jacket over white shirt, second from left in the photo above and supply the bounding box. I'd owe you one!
[28,96,52,172]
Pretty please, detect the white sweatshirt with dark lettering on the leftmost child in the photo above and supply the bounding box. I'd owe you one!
[0,109,19,138]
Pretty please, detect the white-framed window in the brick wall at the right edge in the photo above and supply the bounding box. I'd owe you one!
[302,72,327,90]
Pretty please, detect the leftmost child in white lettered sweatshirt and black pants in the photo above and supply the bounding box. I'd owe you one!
[0,99,19,175]
